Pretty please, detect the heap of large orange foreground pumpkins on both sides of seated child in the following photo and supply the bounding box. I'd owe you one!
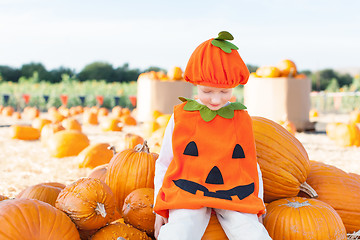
[0,107,360,240]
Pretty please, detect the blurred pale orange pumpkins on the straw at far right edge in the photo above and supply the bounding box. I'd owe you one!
[326,109,360,147]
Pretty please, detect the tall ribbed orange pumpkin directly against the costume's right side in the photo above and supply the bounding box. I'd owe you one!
[252,117,310,202]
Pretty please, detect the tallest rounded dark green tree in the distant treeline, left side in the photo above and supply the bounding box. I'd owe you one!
[77,62,116,82]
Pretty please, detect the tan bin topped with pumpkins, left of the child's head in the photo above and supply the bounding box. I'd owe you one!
[136,78,193,122]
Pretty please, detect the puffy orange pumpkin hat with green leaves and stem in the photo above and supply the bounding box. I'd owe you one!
[184,31,250,88]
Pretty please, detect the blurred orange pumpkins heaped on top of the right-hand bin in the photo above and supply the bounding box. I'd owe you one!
[250,59,307,79]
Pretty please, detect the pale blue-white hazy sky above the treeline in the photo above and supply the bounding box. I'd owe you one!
[0,0,360,71]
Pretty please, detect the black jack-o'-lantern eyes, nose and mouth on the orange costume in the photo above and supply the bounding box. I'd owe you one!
[173,141,254,200]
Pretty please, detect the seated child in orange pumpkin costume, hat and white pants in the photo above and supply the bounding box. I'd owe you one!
[154,32,271,240]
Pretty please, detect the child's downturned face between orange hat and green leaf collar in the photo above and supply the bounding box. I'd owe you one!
[197,85,233,110]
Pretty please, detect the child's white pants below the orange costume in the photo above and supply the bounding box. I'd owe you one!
[158,207,271,240]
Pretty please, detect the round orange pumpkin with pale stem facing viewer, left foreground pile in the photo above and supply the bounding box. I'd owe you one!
[55,178,115,230]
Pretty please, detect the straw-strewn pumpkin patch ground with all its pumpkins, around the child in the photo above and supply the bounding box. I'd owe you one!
[0,107,360,240]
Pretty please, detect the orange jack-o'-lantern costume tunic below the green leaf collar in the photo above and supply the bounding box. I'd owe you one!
[154,99,265,217]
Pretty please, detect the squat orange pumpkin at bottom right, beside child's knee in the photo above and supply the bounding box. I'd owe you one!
[264,197,347,240]
